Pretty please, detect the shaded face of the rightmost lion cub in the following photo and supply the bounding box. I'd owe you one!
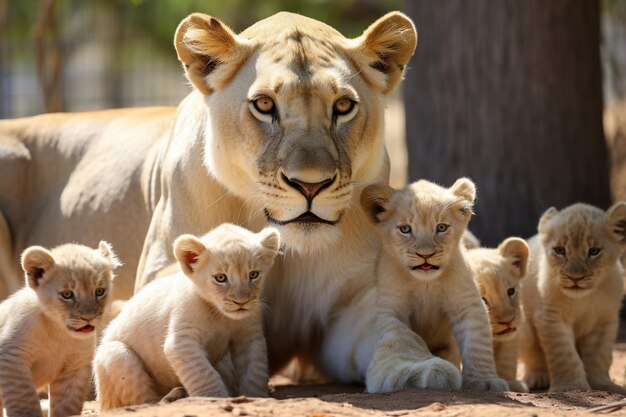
[538,202,626,298]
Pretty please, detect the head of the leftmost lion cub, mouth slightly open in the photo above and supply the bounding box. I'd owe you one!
[22,241,121,338]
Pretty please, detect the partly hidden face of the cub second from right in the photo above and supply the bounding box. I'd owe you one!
[465,237,528,341]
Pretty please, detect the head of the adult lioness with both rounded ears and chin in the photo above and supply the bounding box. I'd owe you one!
[172,13,415,251]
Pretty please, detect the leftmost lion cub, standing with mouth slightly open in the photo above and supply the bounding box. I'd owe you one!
[0,241,121,417]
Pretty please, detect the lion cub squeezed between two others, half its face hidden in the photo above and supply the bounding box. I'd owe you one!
[465,237,528,392]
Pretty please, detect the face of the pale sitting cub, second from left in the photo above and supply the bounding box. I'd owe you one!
[174,223,279,319]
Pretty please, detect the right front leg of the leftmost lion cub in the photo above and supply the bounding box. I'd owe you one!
[48,363,91,417]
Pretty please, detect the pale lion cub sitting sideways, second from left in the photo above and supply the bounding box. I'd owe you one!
[94,224,279,411]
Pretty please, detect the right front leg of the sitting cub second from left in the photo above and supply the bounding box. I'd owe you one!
[232,330,269,397]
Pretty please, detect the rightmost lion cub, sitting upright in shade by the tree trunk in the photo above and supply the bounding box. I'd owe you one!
[520,202,626,394]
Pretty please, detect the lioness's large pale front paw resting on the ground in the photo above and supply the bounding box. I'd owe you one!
[366,357,462,393]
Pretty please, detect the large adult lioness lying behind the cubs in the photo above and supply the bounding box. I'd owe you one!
[0,12,417,381]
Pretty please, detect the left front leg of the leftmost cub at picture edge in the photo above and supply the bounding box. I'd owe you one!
[0,354,41,417]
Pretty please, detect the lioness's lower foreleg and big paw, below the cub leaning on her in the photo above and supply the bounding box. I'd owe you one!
[365,313,461,392]
